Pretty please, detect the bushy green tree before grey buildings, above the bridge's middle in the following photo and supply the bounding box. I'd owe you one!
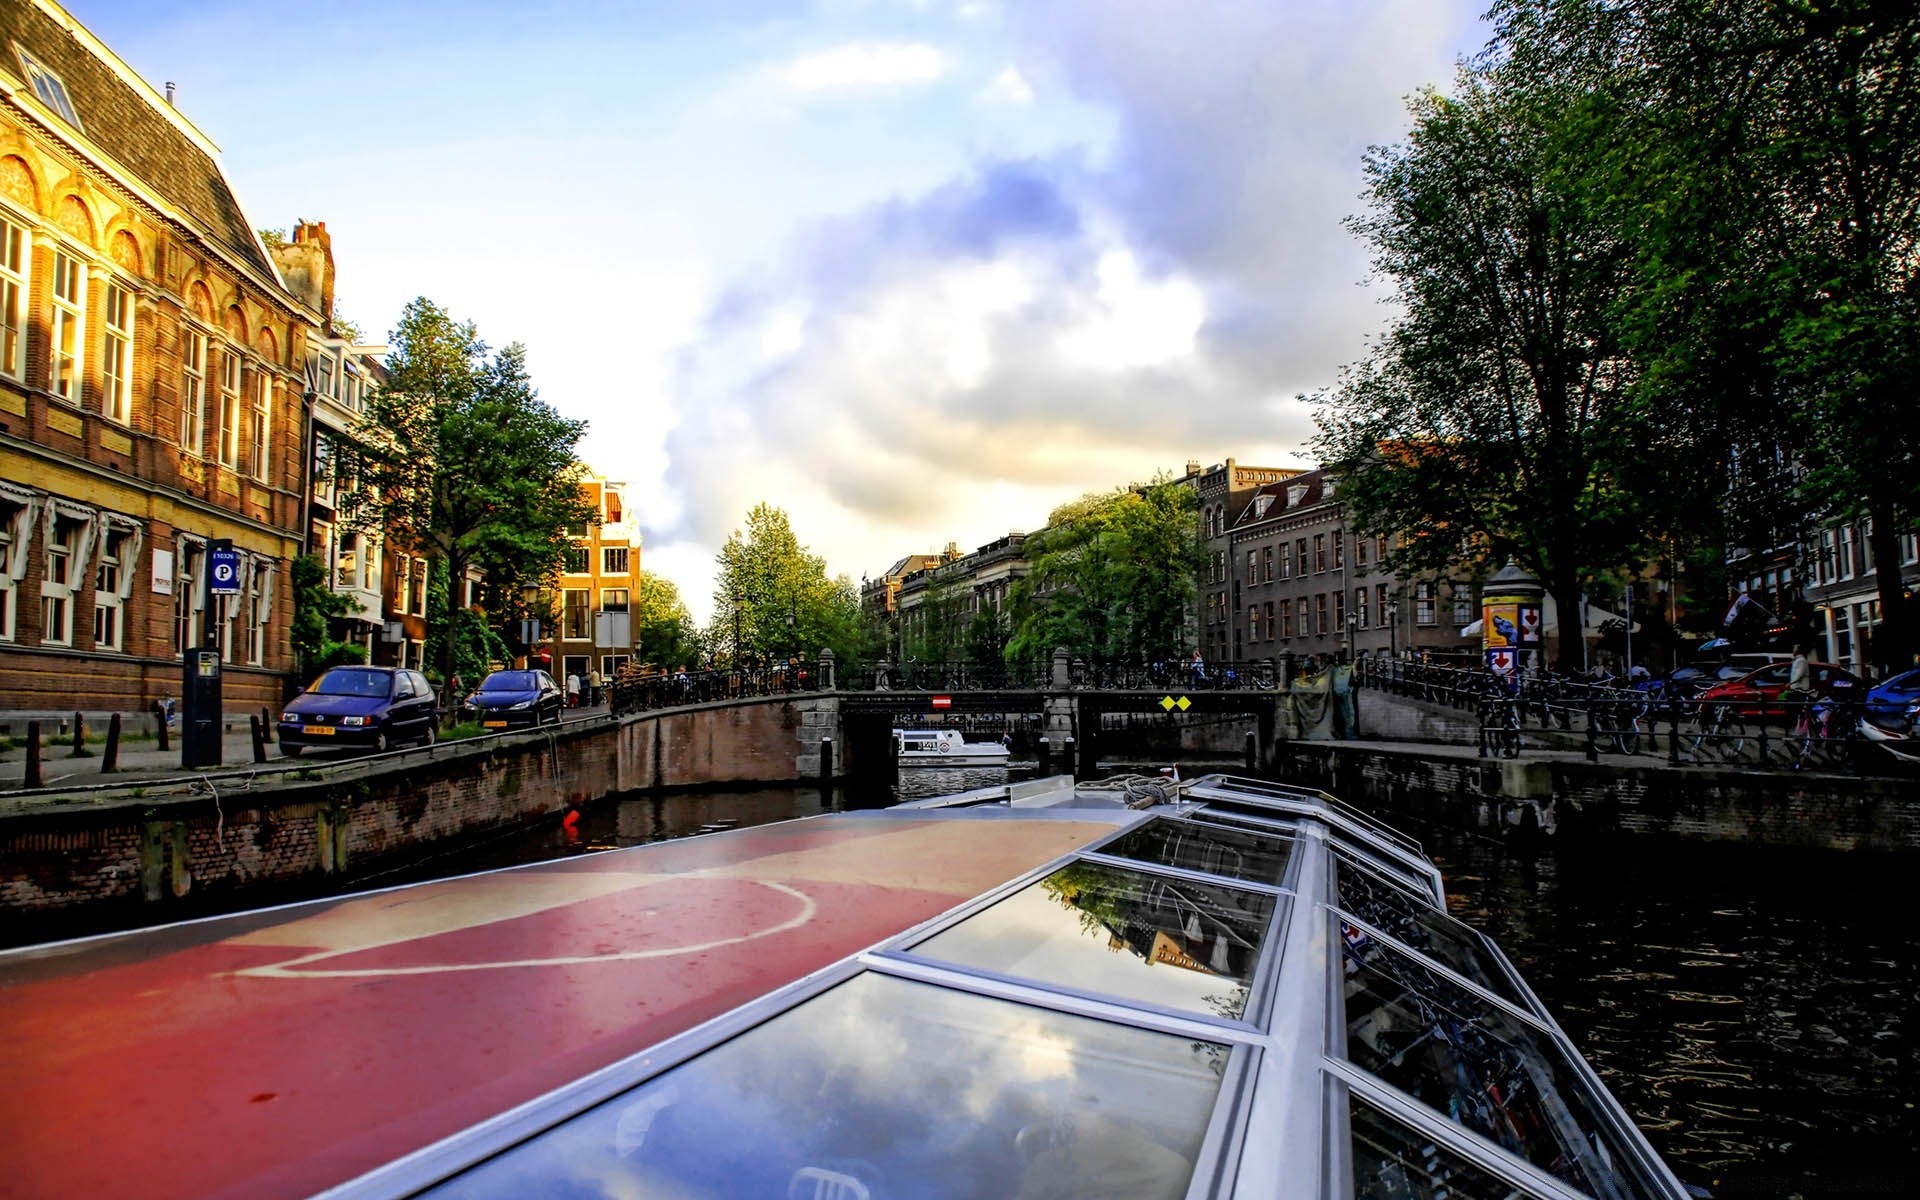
[1004,478,1206,662]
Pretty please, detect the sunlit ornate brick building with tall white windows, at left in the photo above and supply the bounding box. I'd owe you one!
[0,0,321,712]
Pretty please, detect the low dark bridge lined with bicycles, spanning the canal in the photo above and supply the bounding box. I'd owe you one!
[612,651,1284,785]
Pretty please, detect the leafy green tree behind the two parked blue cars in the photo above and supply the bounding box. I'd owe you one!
[344,298,599,674]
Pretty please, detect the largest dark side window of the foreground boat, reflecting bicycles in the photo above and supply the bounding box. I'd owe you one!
[1340,922,1657,1200]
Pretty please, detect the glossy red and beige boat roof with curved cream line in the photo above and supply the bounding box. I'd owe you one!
[0,810,1114,1196]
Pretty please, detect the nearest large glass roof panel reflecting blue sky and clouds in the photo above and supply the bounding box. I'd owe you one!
[428,973,1227,1200]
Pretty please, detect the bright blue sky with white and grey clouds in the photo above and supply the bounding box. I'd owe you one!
[69,0,1486,620]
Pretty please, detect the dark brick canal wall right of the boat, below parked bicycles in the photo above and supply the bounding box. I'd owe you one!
[1275,741,1920,851]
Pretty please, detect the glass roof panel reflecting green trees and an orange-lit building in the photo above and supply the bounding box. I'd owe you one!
[914,862,1275,1020]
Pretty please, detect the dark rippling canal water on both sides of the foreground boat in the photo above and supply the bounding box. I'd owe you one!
[357,766,1920,1200]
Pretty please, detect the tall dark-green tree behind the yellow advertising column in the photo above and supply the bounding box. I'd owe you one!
[1315,63,1663,662]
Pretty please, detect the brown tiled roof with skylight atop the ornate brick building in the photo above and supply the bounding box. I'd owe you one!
[0,0,278,280]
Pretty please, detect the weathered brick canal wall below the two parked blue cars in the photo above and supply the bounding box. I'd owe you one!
[0,697,839,925]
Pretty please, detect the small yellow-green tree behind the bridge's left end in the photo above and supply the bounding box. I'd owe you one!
[705,501,870,666]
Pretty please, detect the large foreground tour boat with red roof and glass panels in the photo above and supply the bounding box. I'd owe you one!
[0,776,1686,1200]
